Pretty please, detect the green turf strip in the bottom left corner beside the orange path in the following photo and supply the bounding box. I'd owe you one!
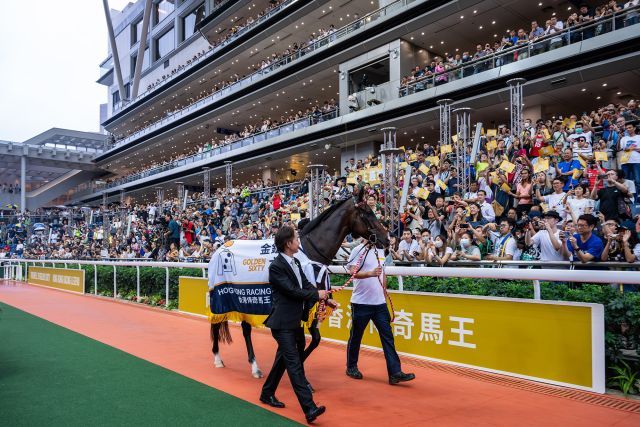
[0,303,298,427]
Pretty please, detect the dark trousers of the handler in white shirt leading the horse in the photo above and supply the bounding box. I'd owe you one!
[347,303,402,375]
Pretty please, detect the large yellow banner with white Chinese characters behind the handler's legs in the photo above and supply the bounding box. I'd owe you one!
[321,290,604,392]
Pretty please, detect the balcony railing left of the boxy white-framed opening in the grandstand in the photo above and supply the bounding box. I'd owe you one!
[106,107,339,188]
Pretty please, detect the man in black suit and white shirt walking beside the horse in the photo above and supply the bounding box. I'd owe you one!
[260,226,327,422]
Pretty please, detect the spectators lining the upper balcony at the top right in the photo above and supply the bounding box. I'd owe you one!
[400,0,640,96]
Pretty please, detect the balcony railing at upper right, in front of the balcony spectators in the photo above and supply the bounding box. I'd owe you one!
[398,6,640,97]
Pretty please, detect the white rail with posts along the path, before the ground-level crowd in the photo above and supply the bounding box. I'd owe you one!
[5,259,640,306]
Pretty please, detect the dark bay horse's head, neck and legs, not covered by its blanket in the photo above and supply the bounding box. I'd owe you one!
[210,191,389,378]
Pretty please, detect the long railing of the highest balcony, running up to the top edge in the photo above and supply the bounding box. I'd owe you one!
[113,0,417,148]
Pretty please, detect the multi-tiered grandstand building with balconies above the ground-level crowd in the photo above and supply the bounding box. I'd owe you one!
[73,0,640,205]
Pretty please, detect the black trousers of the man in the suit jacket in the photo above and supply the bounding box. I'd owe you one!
[262,328,316,414]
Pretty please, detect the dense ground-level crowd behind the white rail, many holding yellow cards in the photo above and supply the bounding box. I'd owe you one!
[0,101,640,265]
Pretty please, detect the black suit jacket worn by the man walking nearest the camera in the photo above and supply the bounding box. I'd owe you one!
[264,254,318,329]
